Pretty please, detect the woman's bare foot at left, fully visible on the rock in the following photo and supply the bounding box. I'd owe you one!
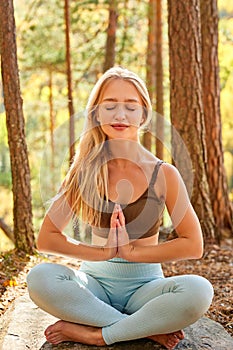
[45,321,106,346]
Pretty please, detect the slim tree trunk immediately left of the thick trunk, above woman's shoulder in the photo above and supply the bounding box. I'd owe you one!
[155,0,164,159]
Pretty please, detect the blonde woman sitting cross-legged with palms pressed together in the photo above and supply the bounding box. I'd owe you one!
[27,67,213,349]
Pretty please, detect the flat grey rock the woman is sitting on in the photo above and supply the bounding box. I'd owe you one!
[0,294,233,350]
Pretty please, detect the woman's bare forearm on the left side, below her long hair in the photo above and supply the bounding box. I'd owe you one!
[37,232,113,261]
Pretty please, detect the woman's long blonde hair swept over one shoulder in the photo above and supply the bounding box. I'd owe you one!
[63,67,152,226]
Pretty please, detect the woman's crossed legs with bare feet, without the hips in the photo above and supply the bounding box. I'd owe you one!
[28,264,211,349]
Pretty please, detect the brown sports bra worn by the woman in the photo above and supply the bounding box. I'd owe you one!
[94,161,165,239]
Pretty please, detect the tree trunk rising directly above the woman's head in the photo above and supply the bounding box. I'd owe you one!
[103,0,118,72]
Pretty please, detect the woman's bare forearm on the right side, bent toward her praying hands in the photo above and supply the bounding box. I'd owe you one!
[121,237,203,263]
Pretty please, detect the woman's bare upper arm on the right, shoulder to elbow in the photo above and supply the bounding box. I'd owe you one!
[162,163,202,239]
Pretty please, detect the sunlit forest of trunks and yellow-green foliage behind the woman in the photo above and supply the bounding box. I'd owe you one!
[0,0,233,340]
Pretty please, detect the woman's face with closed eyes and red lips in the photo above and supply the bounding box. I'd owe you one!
[97,79,144,140]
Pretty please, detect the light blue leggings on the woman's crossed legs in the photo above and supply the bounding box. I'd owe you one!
[27,259,213,345]
